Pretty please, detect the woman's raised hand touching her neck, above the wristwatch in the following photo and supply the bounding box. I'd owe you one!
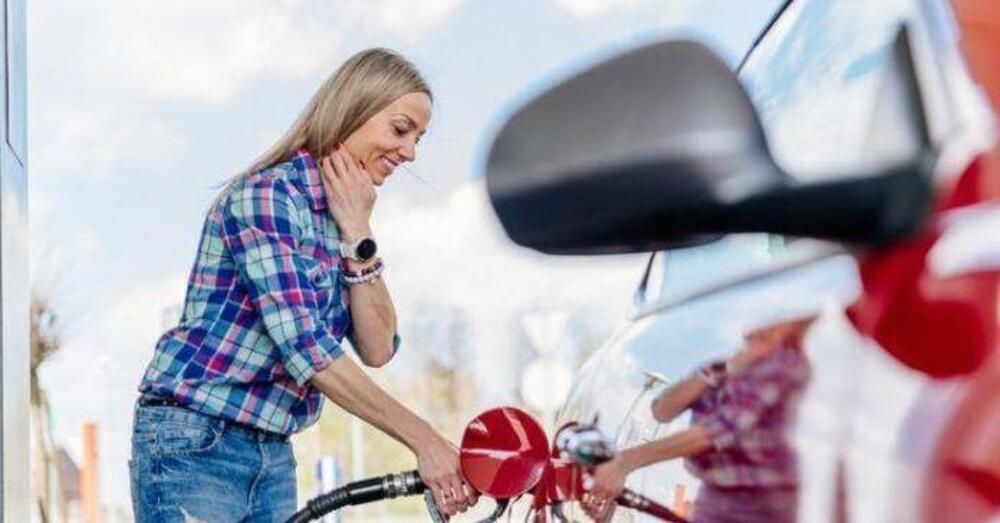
[319,143,375,241]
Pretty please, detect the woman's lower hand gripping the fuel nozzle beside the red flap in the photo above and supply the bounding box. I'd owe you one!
[415,433,479,517]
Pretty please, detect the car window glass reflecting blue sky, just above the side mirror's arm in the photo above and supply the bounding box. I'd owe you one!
[741,0,916,179]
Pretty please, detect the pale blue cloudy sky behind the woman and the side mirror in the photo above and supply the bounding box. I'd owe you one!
[28,0,778,510]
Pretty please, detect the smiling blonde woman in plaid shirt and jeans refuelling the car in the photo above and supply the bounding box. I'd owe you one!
[130,49,476,522]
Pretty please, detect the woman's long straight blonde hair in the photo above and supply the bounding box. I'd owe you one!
[219,48,433,199]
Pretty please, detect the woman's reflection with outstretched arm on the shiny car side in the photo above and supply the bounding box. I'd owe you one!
[584,321,809,523]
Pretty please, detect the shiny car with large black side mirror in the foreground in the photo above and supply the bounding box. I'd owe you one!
[486,0,1000,522]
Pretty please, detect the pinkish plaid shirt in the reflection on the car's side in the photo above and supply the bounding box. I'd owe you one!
[685,347,810,487]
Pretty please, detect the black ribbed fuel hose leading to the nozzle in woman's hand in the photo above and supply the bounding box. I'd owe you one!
[286,470,427,523]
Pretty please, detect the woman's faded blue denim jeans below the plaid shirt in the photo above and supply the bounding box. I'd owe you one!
[129,405,297,523]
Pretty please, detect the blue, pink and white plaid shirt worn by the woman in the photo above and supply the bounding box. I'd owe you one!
[139,151,399,434]
